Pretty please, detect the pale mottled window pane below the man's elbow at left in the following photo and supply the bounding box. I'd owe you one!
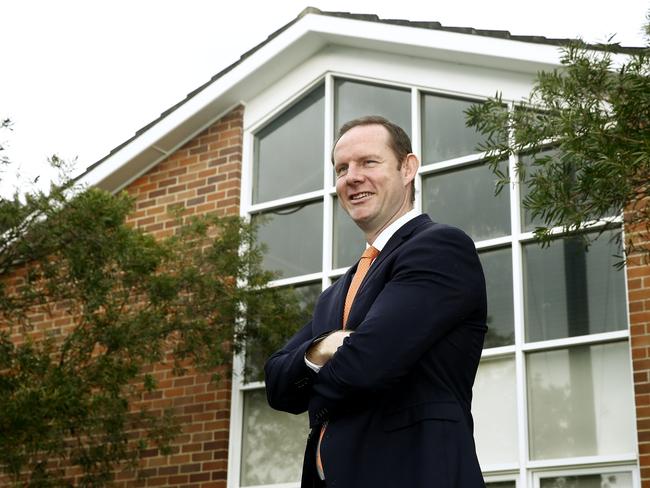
[241,390,309,486]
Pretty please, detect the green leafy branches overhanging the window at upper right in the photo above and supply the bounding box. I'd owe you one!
[467,35,650,260]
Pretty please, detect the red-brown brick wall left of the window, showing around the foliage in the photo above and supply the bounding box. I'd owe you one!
[116,107,244,488]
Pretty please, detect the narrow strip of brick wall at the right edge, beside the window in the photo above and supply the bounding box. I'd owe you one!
[626,204,650,488]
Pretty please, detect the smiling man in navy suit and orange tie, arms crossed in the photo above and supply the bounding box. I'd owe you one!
[265,116,487,488]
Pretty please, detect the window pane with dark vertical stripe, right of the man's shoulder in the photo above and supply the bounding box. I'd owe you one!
[523,231,627,341]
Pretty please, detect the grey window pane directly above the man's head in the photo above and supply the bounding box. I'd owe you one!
[334,79,411,136]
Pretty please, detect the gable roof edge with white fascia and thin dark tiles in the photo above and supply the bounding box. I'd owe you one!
[77,7,643,191]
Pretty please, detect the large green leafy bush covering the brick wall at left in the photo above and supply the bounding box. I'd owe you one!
[0,129,299,486]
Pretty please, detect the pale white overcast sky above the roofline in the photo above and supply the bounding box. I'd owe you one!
[0,0,650,194]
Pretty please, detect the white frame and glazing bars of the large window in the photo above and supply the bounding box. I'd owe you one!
[228,62,640,488]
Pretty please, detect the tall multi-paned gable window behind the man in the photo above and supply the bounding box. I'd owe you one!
[231,75,638,488]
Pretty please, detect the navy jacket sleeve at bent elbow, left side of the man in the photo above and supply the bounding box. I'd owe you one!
[264,321,324,414]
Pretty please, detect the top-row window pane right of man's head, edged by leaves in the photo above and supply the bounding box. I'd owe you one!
[422,95,483,164]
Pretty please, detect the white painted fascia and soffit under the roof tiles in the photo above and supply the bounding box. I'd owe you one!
[79,13,560,191]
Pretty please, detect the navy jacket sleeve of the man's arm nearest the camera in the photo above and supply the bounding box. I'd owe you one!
[309,227,485,418]
